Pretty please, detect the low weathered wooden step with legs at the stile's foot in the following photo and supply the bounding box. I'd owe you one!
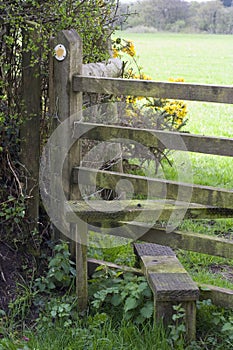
[134,243,199,340]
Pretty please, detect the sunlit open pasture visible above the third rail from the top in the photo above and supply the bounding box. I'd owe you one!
[116,31,233,189]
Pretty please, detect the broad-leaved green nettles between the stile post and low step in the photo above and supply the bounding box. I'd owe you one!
[90,267,154,324]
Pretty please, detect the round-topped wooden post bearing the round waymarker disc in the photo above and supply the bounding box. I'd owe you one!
[50,29,88,311]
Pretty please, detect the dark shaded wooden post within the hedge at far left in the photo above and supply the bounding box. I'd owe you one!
[20,22,41,231]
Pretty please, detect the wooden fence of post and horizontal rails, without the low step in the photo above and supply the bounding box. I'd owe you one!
[44,30,233,326]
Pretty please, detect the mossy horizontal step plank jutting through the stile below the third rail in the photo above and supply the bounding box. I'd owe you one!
[66,200,233,226]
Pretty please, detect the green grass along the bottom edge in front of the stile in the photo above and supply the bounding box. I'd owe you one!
[0,315,174,350]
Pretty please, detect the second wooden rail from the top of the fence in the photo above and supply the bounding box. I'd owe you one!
[74,122,233,157]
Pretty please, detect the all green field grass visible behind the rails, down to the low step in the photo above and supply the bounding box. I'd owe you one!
[111,31,233,288]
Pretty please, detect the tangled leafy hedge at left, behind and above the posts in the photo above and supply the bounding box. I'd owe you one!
[0,0,117,241]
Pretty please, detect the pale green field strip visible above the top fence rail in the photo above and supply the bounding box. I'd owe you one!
[115,31,233,85]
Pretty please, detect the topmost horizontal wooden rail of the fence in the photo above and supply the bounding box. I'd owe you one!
[73,75,233,104]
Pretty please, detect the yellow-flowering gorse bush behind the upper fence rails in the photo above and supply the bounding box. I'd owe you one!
[112,38,187,173]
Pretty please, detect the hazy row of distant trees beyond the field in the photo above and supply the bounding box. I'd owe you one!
[118,0,233,34]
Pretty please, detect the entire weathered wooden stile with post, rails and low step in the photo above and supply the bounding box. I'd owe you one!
[46,30,233,328]
